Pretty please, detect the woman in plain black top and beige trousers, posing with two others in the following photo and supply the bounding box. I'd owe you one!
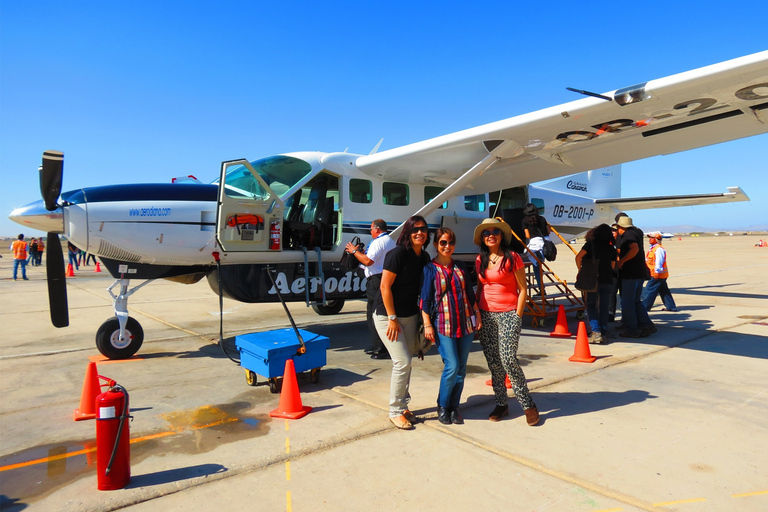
[373,215,430,430]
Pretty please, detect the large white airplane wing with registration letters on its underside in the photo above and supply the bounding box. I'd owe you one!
[356,51,768,194]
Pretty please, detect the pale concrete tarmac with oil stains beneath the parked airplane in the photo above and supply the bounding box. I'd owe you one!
[0,236,768,512]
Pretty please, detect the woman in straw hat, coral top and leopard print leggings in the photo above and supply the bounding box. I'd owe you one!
[474,217,539,426]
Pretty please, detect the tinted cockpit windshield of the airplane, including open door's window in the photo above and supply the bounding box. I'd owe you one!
[214,155,312,200]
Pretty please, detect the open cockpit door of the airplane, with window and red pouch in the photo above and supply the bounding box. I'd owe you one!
[216,160,285,252]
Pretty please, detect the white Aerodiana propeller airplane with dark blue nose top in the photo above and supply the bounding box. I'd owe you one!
[10,51,768,359]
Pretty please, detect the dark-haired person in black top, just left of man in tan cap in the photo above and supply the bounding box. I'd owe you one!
[576,224,616,344]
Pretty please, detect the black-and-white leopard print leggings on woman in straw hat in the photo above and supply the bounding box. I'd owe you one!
[480,310,536,410]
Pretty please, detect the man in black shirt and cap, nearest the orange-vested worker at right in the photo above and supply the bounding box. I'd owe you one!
[616,216,656,338]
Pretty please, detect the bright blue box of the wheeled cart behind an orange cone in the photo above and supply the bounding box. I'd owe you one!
[235,329,331,379]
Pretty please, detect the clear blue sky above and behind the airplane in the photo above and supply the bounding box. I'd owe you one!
[0,0,768,236]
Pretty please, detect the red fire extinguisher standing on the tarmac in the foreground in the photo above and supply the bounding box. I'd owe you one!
[96,384,131,491]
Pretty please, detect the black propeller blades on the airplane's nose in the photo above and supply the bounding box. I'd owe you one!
[40,150,69,327]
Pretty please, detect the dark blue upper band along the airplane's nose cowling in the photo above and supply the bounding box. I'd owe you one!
[61,183,219,204]
